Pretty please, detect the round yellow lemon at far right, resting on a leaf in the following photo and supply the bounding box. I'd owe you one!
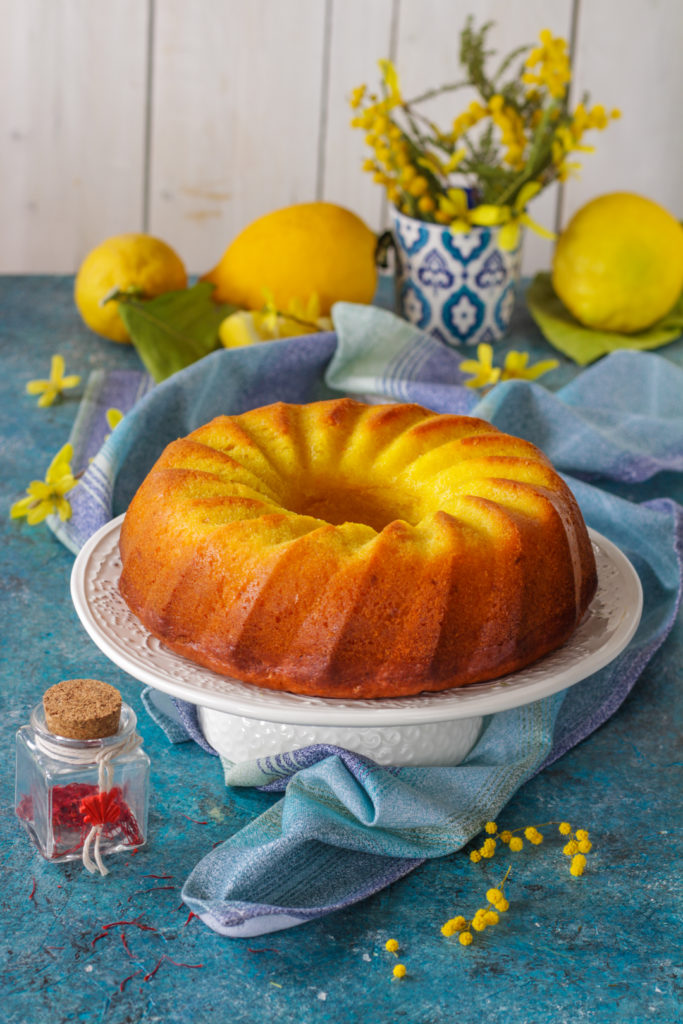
[552,193,683,334]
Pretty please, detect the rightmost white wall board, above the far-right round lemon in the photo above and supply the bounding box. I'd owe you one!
[563,0,683,224]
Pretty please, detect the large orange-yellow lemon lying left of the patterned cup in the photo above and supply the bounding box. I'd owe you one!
[204,203,377,315]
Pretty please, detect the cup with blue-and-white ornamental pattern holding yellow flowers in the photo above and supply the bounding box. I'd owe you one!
[392,210,521,345]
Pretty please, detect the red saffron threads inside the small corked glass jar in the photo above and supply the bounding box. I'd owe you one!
[16,782,143,858]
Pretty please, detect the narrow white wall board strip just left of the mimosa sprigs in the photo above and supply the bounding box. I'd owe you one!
[322,0,398,231]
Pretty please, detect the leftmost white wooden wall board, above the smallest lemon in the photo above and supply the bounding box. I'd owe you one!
[0,0,147,273]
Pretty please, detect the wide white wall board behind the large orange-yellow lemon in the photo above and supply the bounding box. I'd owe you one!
[150,0,326,272]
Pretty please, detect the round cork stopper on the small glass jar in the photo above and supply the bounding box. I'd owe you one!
[43,679,121,739]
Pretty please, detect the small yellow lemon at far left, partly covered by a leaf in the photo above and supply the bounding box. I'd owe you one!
[74,234,187,341]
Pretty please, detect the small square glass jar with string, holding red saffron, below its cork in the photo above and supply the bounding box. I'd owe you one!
[14,702,150,874]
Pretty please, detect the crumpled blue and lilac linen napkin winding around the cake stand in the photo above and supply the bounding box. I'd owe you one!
[52,304,683,936]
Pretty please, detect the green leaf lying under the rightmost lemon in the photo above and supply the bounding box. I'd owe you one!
[526,273,683,367]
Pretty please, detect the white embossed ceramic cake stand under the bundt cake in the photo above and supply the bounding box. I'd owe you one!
[71,516,643,765]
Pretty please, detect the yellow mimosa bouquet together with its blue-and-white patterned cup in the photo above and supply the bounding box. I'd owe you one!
[350,18,620,344]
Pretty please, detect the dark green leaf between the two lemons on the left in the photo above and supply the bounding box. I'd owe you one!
[117,281,237,384]
